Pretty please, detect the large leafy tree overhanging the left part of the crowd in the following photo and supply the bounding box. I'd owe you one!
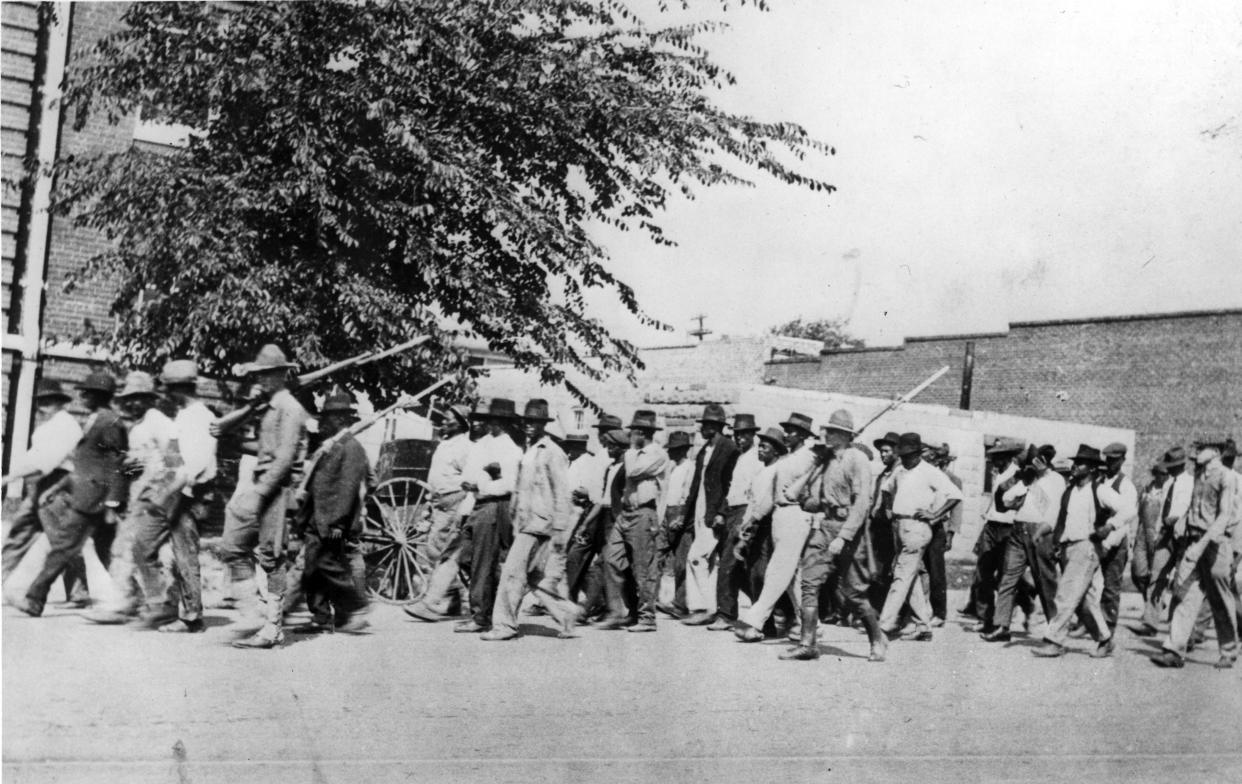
[57,0,835,399]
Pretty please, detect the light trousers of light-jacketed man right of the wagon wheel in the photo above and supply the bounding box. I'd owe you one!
[492,532,578,631]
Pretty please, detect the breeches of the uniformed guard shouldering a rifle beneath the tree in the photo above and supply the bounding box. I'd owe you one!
[220,487,288,635]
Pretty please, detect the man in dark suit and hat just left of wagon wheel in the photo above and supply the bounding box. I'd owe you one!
[294,393,370,632]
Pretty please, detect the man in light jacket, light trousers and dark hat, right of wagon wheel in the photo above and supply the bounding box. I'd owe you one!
[479,399,580,641]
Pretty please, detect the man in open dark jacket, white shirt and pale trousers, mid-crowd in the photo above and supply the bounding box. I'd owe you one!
[682,404,738,626]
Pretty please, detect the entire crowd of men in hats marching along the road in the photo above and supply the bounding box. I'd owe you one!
[4,345,1242,668]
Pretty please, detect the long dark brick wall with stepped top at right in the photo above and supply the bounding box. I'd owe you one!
[764,311,1242,475]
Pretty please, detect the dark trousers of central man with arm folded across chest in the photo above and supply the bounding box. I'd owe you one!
[604,507,660,626]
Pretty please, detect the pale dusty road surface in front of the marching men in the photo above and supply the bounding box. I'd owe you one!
[2,596,1242,784]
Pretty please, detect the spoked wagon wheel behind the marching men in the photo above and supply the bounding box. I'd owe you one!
[360,477,431,604]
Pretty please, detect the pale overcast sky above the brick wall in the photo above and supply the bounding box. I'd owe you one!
[581,0,1242,345]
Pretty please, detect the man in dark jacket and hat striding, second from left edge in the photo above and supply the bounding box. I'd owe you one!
[16,371,129,618]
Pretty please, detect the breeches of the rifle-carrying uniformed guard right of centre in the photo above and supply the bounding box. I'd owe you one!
[801,527,881,645]
